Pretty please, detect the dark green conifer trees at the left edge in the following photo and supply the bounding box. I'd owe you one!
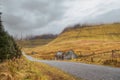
[0,13,22,62]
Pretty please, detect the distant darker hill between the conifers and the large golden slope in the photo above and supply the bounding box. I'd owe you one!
[16,34,57,48]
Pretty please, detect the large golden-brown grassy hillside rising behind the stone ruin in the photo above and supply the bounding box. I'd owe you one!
[25,23,120,67]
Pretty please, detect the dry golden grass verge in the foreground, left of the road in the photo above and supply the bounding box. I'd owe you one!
[0,58,77,80]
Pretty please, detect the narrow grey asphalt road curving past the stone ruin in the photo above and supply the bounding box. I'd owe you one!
[23,53,120,80]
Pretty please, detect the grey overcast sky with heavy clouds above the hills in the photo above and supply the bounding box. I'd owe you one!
[0,0,120,36]
